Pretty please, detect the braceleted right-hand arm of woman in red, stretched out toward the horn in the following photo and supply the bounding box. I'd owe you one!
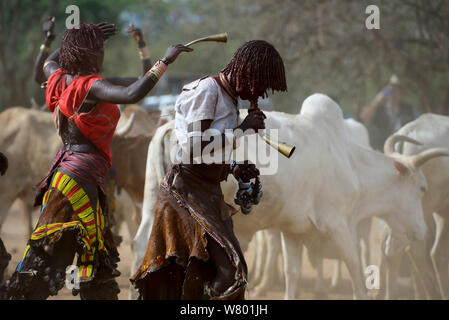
[88,44,193,104]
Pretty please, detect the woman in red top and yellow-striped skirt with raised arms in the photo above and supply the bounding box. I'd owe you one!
[4,23,192,299]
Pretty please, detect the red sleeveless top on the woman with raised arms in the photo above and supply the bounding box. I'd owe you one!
[45,69,120,165]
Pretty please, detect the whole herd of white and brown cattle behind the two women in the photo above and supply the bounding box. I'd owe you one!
[0,94,449,299]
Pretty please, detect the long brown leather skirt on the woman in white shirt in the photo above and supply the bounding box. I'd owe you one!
[130,165,247,300]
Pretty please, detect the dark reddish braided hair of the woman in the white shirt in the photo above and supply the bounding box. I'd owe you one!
[221,40,287,97]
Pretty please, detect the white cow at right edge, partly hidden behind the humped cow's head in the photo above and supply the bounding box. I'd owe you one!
[382,113,449,299]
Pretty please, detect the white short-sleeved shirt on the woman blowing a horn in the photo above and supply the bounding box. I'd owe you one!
[175,77,239,161]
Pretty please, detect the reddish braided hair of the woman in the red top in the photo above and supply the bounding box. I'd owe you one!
[59,23,104,74]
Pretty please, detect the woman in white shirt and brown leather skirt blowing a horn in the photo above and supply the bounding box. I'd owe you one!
[131,40,287,300]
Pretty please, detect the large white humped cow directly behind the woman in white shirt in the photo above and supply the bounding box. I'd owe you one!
[134,94,442,299]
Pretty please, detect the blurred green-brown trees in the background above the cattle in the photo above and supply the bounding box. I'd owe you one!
[0,0,449,115]
